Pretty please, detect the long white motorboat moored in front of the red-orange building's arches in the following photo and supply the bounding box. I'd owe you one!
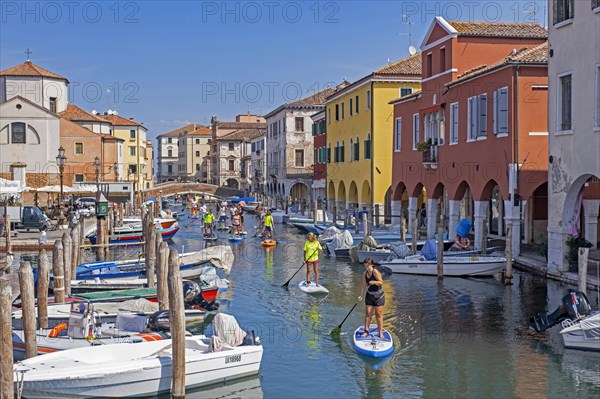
[381,255,506,277]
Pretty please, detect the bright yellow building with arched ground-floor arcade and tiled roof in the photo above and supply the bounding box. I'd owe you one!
[326,53,421,222]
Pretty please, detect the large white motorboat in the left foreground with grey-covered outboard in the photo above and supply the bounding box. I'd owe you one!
[13,322,263,398]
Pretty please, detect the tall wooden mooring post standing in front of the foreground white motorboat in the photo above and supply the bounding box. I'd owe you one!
[168,250,185,399]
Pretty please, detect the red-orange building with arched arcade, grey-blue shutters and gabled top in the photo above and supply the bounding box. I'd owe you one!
[391,17,548,255]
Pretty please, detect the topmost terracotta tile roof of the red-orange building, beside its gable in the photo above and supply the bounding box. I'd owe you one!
[448,21,548,39]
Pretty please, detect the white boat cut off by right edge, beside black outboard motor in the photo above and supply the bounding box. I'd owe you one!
[560,310,600,351]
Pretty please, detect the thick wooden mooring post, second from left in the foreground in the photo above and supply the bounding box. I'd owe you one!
[19,262,37,359]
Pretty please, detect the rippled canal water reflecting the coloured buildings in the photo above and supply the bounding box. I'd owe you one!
[9,216,600,399]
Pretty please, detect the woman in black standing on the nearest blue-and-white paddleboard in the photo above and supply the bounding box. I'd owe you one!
[358,258,385,338]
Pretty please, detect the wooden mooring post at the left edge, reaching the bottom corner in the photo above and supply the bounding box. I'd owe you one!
[0,276,15,398]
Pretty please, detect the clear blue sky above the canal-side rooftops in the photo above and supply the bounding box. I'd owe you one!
[0,0,547,138]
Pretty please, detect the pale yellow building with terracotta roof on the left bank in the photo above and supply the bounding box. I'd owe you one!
[103,114,152,191]
